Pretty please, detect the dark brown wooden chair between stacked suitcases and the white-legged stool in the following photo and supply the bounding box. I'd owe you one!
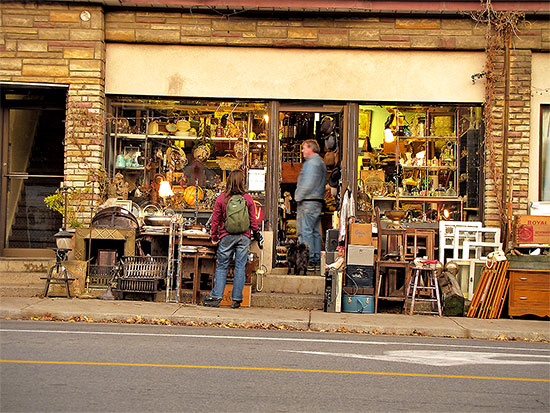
[374,207,409,312]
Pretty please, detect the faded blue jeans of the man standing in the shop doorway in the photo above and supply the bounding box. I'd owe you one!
[296,201,323,266]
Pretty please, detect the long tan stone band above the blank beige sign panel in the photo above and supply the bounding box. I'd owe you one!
[105,10,550,50]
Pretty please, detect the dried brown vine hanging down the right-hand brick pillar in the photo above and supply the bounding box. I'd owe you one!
[471,0,525,224]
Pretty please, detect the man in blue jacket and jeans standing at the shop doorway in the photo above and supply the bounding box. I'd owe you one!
[294,139,327,272]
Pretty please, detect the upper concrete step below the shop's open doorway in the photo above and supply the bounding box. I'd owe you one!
[262,273,325,295]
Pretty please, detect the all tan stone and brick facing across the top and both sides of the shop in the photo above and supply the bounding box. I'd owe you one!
[0,2,550,226]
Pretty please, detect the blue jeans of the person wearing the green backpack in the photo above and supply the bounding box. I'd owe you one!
[210,234,250,301]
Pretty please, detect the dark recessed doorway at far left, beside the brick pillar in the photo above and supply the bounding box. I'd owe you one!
[0,85,66,257]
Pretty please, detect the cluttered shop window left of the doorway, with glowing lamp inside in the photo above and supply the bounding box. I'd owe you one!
[106,97,269,217]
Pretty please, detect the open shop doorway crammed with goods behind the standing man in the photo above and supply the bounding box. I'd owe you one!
[274,105,344,267]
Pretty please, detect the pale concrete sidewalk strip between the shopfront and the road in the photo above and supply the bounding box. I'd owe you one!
[0,297,550,341]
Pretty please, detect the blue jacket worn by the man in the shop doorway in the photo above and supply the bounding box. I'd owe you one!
[294,153,327,202]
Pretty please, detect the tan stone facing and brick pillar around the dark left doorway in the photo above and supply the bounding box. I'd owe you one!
[0,2,105,218]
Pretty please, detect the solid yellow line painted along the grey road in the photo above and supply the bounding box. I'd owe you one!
[0,360,550,382]
